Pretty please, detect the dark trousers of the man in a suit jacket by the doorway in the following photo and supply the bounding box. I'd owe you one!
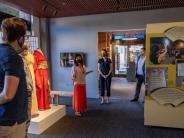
[134,75,144,99]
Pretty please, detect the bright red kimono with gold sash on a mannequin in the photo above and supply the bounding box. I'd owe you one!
[34,49,49,110]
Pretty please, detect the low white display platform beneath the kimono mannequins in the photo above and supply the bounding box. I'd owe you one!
[28,105,66,134]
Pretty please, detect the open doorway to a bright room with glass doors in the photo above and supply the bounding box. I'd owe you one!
[98,30,145,100]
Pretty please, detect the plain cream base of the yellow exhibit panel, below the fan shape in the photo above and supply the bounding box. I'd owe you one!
[144,97,184,128]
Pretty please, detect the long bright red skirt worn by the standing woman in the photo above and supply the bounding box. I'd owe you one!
[73,84,87,112]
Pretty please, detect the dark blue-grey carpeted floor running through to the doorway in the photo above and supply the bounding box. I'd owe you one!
[28,79,184,138]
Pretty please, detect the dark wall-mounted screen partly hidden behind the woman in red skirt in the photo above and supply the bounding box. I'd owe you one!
[60,52,86,67]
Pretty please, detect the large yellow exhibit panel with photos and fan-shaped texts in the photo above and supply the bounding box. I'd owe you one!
[144,22,184,128]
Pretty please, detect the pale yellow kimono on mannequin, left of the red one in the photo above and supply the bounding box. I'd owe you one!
[24,52,39,117]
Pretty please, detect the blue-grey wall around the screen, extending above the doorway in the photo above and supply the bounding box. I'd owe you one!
[50,8,184,98]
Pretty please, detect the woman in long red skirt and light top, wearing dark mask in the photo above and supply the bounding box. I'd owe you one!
[72,54,87,116]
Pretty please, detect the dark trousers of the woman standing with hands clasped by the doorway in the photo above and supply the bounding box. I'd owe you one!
[100,76,111,97]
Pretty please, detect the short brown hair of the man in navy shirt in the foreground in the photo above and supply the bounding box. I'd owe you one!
[1,17,27,42]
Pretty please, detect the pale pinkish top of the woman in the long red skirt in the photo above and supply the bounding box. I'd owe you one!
[71,65,86,85]
